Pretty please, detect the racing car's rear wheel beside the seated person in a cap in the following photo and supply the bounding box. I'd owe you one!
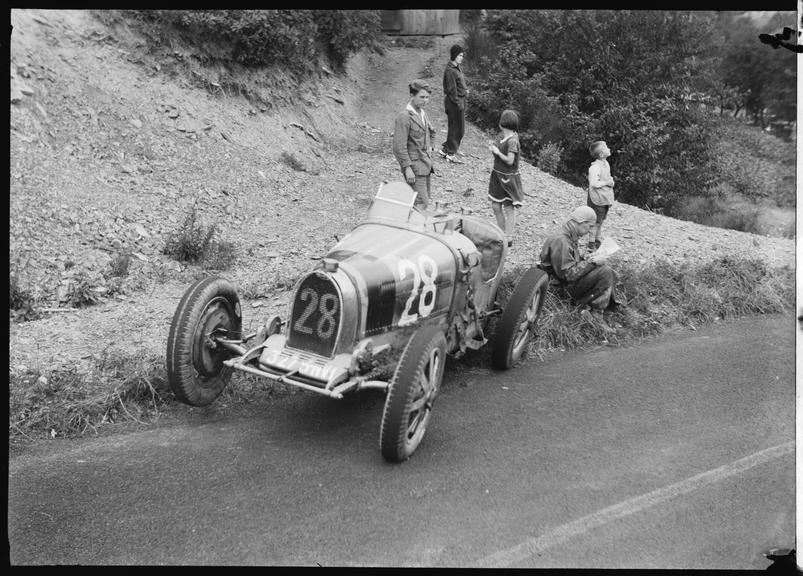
[491,266,549,370]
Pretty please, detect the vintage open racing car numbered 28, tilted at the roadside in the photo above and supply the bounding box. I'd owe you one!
[167,182,548,462]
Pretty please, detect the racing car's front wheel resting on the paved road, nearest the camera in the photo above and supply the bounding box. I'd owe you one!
[379,326,446,462]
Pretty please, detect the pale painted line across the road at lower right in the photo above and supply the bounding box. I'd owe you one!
[477,441,795,568]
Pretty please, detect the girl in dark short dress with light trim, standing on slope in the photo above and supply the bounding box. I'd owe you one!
[488,110,523,246]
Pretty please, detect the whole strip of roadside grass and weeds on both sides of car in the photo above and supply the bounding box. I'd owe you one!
[9,257,795,442]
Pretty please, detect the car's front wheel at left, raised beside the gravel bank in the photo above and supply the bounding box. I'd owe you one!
[167,276,242,406]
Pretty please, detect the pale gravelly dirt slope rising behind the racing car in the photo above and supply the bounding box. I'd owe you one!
[9,10,795,371]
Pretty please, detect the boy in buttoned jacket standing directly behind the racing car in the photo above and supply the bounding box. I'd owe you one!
[393,80,435,209]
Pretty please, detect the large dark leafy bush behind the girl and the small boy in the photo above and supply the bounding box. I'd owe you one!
[467,10,728,213]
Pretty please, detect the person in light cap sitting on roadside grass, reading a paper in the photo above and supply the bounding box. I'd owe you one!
[541,206,621,312]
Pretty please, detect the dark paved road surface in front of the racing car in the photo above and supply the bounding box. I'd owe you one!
[8,316,795,569]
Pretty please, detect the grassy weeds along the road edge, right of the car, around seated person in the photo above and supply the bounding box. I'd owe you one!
[500,256,795,355]
